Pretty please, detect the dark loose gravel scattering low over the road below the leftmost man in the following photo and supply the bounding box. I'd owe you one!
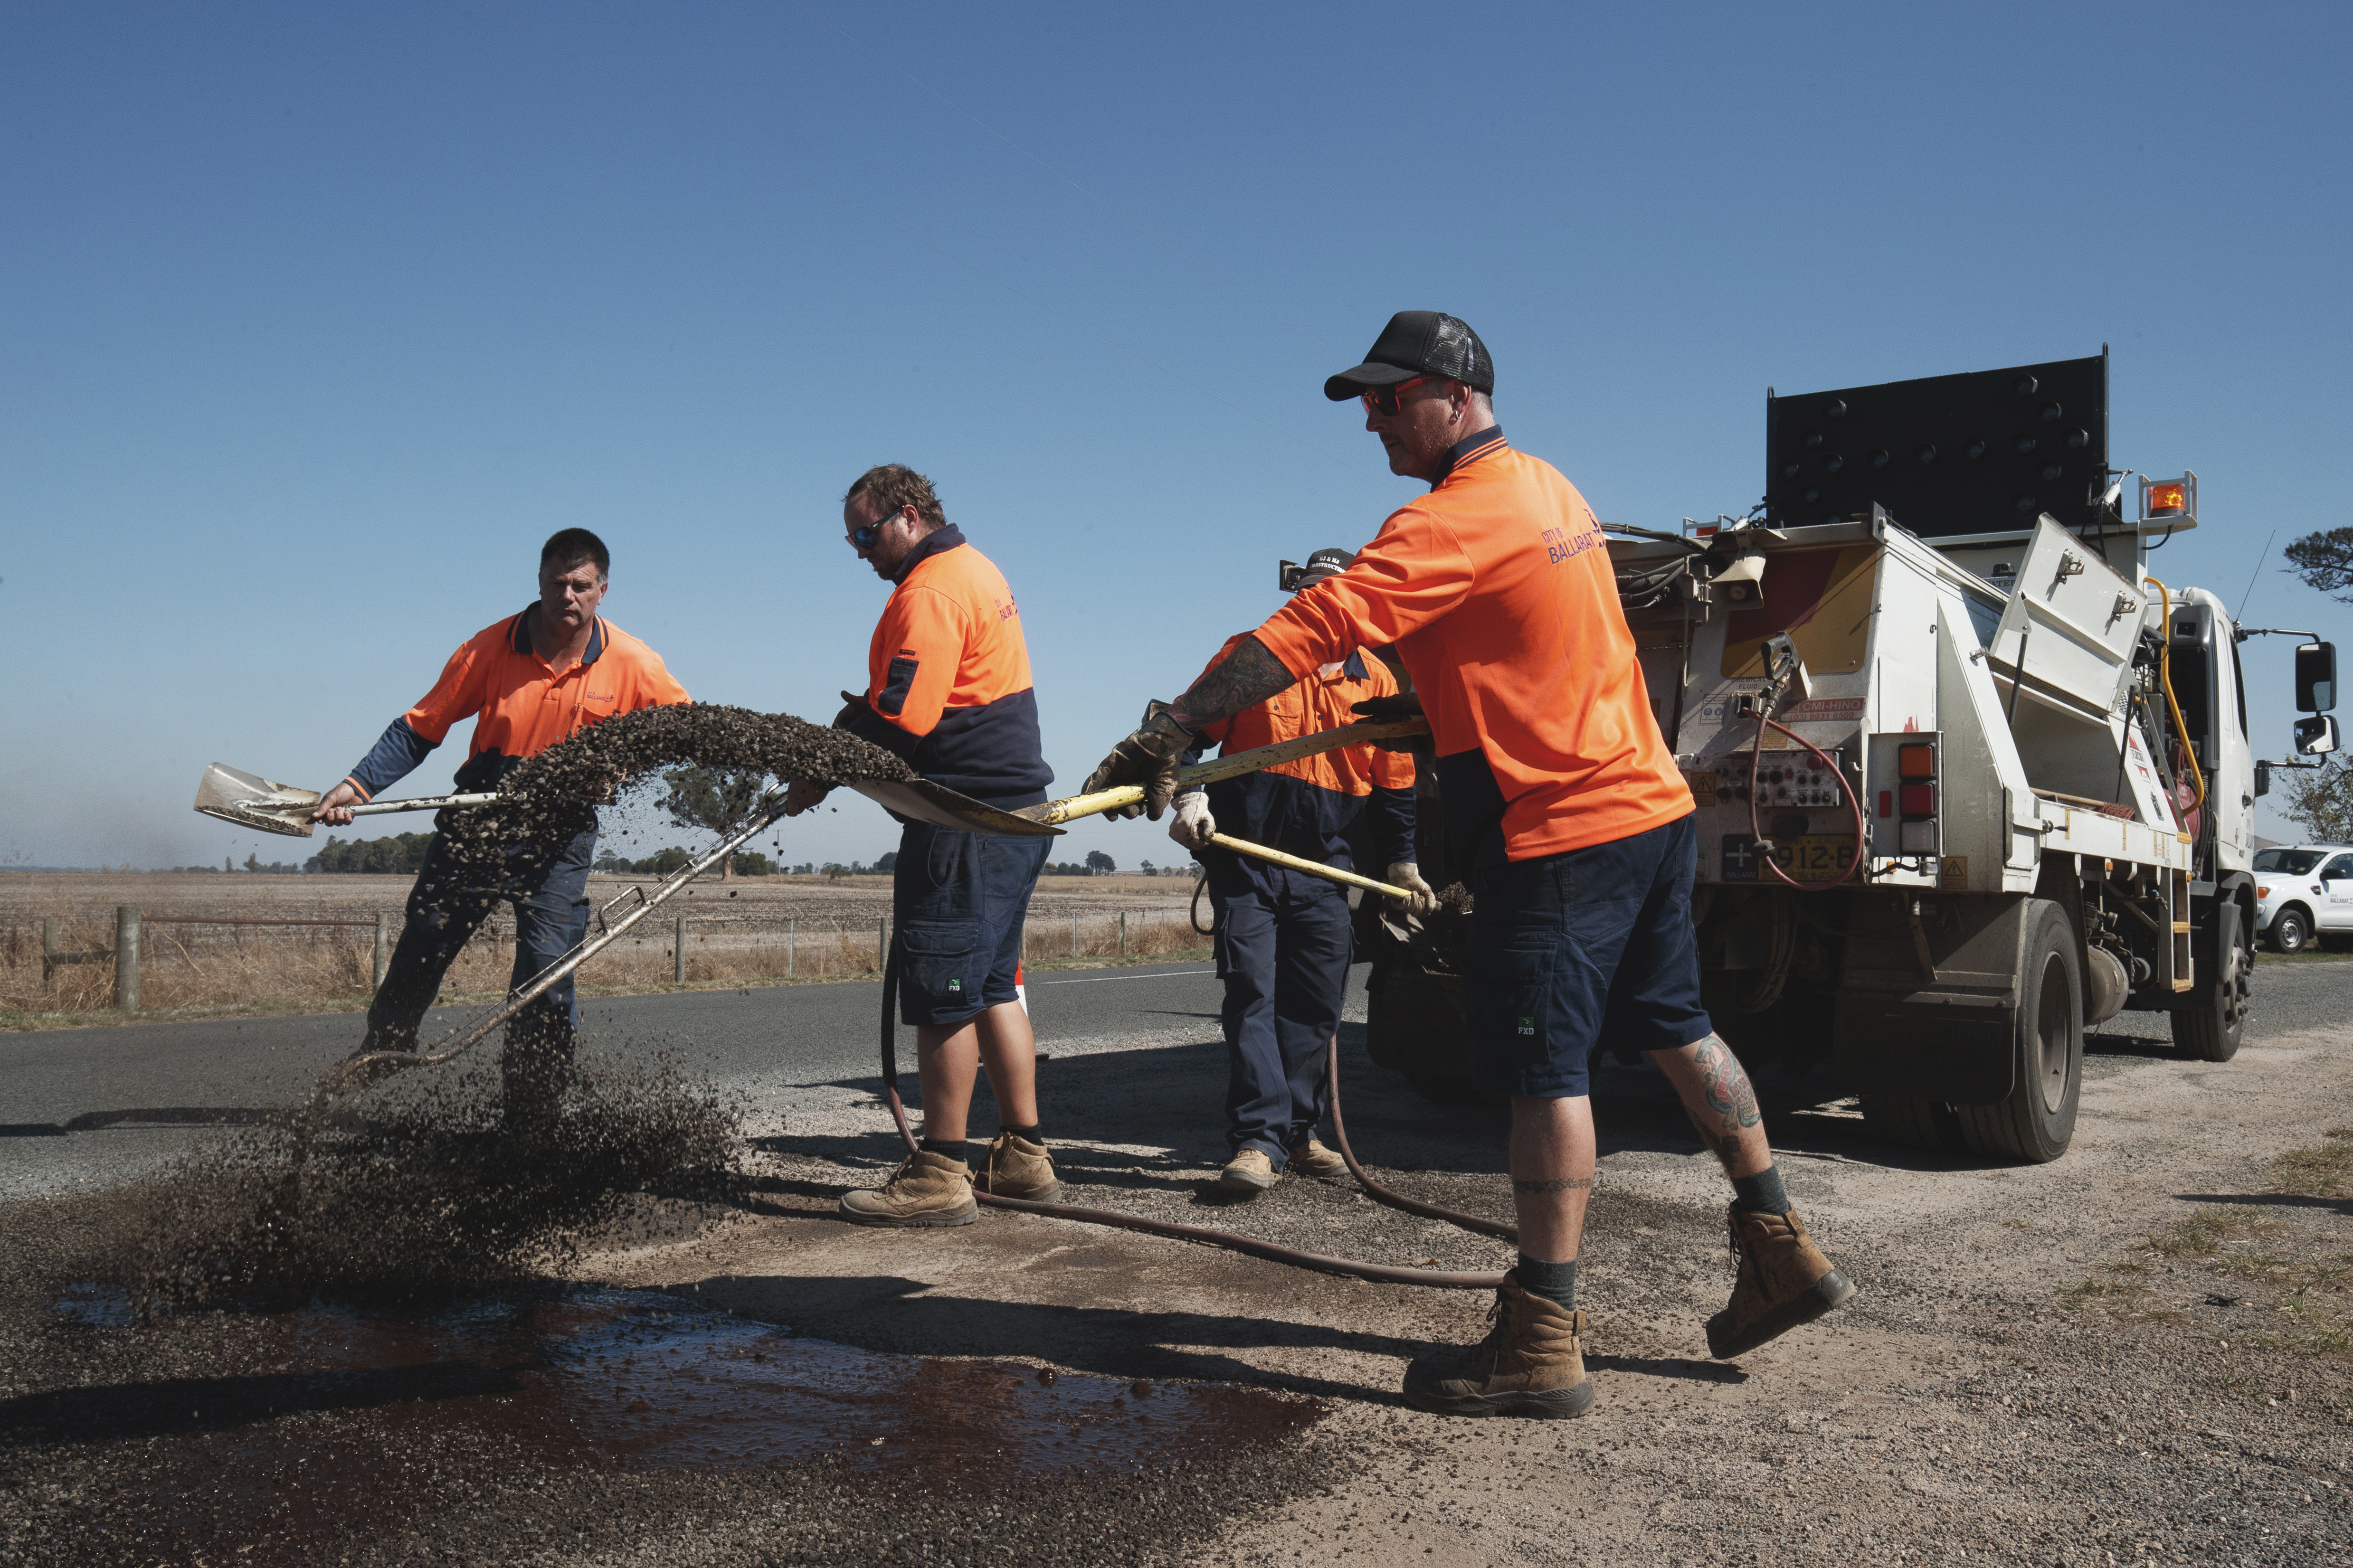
[99,1060,743,1312]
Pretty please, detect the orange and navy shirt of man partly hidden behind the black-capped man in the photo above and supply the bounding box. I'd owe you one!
[1186,633,1414,881]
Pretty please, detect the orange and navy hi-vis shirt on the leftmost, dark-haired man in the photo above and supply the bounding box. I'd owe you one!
[348,609,690,797]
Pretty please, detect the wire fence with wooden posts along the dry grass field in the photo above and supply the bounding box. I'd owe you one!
[0,905,1207,1013]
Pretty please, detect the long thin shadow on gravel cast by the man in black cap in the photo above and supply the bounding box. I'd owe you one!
[694,1279,1739,1406]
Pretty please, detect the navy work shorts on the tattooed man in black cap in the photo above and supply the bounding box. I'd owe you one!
[1463,816,1715,1100]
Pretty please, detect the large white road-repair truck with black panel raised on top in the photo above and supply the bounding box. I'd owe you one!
[1369,353,2336,1162]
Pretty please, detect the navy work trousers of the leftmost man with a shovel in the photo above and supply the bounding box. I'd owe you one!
[365,828,595,1116]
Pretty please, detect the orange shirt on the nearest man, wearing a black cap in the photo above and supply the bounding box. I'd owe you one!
[1256,428,1692,870]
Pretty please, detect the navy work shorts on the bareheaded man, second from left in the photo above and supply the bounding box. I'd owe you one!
[892,823,1054,1025]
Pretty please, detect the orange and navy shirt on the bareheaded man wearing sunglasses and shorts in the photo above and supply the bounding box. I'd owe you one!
[835,524,1054,809]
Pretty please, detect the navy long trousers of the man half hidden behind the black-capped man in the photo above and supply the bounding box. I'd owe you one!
[1200,849,1356,1171]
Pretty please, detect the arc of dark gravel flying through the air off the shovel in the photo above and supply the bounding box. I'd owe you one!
[442,703,915,849]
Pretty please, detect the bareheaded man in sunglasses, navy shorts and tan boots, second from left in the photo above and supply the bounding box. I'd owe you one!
[784,463,1061,1227]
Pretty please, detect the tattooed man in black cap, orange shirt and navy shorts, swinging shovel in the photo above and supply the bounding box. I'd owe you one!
[1087,310,1854,1417]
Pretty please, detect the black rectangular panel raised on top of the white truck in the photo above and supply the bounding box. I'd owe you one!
[1765,355,2108,538]
